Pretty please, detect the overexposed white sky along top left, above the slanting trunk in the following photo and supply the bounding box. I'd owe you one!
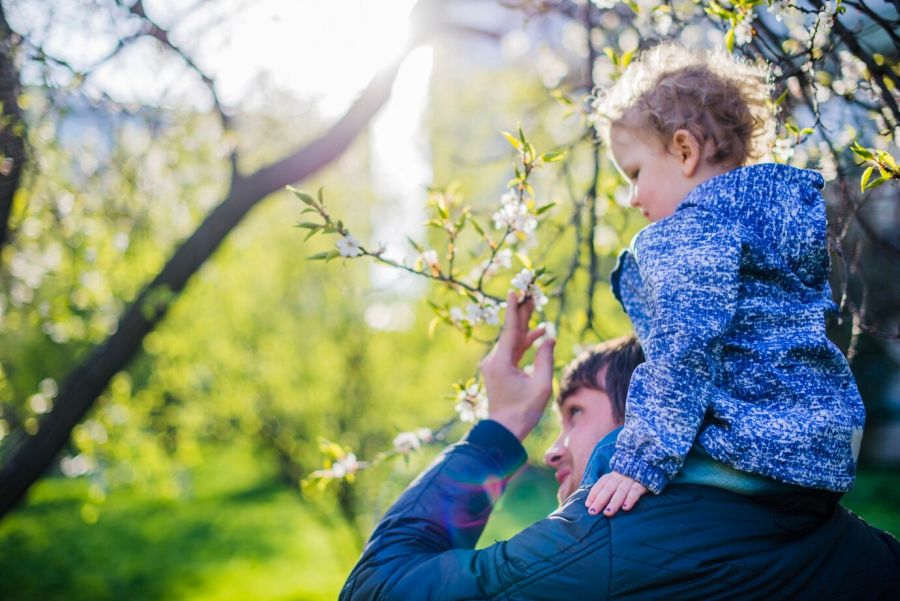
[8,0,415,116]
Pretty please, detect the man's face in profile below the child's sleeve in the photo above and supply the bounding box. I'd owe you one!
[544,382,621,504]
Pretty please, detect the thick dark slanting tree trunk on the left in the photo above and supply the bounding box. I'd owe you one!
[0,41,414,516]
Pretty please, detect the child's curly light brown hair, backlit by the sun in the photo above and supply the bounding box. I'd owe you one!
[595,44,775,166]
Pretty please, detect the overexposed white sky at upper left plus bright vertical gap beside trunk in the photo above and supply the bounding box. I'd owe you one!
[11,0,448,329]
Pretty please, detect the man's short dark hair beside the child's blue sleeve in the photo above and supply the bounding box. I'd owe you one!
[557,336,644,422]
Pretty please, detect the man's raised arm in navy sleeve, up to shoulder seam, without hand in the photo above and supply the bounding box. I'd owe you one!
[340,420,609,601]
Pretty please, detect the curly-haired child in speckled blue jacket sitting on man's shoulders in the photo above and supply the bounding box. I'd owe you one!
[585,45,865,516]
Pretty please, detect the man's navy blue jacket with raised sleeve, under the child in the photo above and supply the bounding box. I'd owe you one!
[340,420,900,601]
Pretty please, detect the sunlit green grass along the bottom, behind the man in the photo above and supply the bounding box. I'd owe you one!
[0,448,900,601]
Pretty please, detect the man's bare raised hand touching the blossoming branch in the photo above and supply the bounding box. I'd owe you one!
[481,292,556,440]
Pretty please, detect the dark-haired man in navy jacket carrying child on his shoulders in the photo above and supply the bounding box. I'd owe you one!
[341,295,900,601]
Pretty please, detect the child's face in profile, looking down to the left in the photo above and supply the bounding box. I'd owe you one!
[610,125,696,221]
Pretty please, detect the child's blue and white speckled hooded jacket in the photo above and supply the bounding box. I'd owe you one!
[610,163,865,493]
